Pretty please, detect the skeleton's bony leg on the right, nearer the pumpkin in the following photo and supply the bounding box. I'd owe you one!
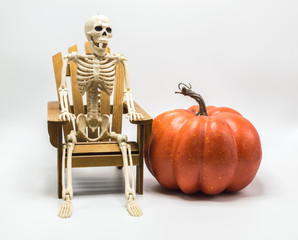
[111,132,143,217]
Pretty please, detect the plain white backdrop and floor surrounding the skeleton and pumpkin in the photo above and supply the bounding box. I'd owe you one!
[0,0,298,240]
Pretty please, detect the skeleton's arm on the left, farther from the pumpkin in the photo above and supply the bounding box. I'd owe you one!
[58,53,76,121]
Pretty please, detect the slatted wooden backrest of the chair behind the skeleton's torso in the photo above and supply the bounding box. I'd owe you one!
[53,42,125,141]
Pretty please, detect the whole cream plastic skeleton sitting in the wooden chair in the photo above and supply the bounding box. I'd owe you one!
[58,15,143,218]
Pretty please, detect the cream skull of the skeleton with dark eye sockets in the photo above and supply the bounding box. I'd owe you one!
[85,14,112,56]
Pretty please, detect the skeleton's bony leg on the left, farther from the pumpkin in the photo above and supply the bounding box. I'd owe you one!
[58,131,76,218]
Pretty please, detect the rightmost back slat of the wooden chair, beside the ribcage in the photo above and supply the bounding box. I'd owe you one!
[112,62,125,133]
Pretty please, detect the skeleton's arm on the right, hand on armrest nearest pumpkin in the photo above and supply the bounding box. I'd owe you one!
[121,58,143,121]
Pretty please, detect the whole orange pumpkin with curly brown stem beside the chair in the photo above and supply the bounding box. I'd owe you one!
[145,85,262,195]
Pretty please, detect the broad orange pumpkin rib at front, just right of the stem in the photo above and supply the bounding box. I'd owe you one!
[201,116,237,195]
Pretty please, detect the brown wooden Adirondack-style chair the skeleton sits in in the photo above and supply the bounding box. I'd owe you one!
[48,42,152,198]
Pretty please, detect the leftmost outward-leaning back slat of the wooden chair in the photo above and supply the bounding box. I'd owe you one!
[52,52,73,138]
